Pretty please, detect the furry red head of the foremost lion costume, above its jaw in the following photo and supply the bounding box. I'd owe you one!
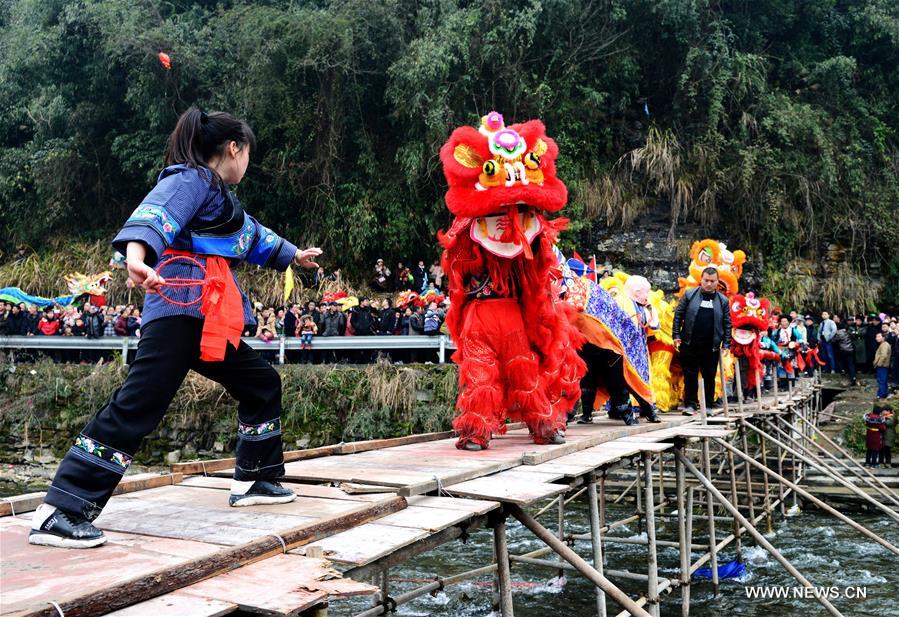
[440,111,568,218]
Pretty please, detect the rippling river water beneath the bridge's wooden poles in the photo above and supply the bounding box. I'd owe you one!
[329,503,899,617]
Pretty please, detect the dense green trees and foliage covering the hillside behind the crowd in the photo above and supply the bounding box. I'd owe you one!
[0,0,899,304]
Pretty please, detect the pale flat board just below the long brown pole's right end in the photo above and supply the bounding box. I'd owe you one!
[298,522,430,566]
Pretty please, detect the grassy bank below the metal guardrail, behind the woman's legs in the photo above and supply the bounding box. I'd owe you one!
[0,361,456,464]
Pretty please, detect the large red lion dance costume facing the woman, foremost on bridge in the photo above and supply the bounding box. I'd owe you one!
[438,112,585,450]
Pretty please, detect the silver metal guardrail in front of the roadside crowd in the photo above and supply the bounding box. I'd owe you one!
[0,334,456,366]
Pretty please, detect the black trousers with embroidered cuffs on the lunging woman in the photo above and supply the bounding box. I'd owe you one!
[45,316,284,520]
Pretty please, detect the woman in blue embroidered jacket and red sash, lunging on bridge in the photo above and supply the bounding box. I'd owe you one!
[29,109,321,548]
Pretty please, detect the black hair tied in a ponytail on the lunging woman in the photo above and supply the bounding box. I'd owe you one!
[165,107,256,179]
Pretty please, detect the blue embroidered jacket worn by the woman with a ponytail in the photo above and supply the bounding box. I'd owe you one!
[112,165,297,325]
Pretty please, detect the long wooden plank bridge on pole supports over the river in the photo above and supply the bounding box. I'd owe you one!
[0,381,899,617]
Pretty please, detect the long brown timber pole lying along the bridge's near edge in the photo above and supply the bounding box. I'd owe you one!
[4,497,406,617]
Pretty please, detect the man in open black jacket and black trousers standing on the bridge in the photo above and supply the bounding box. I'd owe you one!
[672,268,731,416]
